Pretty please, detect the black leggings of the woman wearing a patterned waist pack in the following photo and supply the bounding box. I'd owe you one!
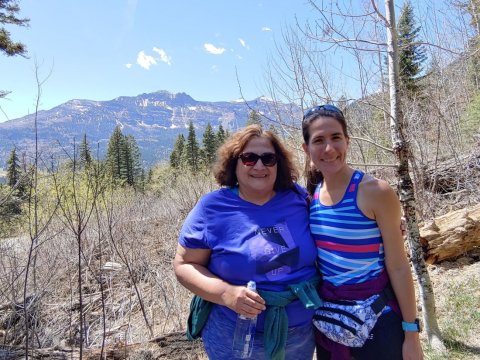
[315,311,405,360]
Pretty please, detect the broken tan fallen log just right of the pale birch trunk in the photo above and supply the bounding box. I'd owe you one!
[420,204,480,264]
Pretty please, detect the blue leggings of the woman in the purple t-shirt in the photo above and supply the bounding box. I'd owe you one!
[202,306,315,360]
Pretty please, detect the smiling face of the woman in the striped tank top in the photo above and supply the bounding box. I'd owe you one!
[303,116,349,176]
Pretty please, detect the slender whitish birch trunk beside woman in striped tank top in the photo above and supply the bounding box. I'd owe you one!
[385,0,445,350]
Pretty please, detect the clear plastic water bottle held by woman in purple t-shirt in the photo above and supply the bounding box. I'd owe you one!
[233,281,257,359]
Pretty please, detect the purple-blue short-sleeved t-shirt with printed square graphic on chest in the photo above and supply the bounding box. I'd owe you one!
[179,186,316,329]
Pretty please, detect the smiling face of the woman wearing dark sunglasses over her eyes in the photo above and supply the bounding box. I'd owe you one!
[235,136,277,202]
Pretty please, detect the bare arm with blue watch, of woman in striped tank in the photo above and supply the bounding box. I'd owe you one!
[359,179,423,359]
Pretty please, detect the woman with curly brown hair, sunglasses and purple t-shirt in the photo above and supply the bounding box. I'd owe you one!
[174,125,319,360]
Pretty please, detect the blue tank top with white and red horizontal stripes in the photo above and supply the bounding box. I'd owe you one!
[310,170,385,286]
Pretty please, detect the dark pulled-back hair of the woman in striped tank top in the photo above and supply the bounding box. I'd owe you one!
[302,105,349,196]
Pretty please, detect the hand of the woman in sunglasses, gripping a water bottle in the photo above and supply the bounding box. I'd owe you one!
[222,285,266,317]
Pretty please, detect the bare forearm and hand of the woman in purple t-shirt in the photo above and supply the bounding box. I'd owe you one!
[173,244,265,317]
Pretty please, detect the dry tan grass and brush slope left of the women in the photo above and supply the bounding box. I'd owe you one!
[0,171,214,358]
